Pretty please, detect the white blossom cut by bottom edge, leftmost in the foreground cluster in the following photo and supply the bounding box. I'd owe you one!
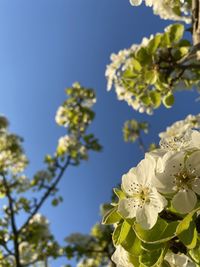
[111,245,134,267]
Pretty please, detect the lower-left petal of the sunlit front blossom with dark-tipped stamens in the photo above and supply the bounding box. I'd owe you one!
[118,198,139,218]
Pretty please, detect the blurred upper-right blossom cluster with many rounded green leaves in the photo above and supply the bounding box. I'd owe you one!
[105,24,195,114]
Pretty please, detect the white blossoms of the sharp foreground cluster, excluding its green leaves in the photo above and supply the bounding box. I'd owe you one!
[108,114,200,267]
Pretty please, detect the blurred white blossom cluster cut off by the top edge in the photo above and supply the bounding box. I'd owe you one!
[130,0,191,23]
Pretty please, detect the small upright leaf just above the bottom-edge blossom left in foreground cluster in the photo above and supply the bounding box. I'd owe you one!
[112,221,131,246]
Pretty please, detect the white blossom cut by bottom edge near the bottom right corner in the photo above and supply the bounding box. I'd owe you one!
[165,252,196,267]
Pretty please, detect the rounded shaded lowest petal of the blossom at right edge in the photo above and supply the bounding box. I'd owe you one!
[172,189,197,214]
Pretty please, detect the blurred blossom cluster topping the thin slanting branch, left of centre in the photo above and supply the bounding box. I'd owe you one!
[55,83,101,164]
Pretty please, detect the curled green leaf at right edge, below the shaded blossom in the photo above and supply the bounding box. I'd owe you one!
[176,210,198,249]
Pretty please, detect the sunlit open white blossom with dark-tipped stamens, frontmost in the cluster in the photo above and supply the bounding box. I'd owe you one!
[118,157,167,229]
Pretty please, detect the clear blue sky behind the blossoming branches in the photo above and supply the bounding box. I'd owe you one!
[0,0,200,267]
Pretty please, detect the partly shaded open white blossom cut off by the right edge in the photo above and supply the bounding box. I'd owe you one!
[154,150,200,214]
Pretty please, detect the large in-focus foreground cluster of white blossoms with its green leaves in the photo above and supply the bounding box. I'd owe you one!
[104,114,200,267]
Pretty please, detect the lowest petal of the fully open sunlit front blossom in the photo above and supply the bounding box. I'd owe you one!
[136,204,158,229]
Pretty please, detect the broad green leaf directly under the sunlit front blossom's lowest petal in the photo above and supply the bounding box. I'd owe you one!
[134,218,179,244]
